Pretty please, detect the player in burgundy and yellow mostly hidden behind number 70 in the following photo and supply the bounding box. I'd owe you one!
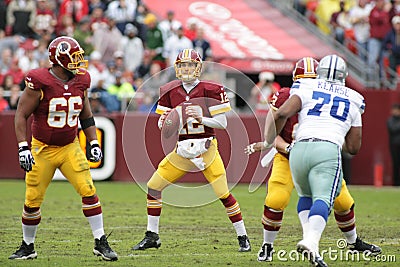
[245,57,381,261]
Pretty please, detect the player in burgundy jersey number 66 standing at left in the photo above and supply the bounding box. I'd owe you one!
[9,36,118,261]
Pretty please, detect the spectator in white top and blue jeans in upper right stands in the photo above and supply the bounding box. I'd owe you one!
[349,0,373,62]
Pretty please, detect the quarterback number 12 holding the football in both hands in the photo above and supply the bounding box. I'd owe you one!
[133,49,251,252]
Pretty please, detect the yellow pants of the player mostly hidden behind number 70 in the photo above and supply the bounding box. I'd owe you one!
[265,153,354,212]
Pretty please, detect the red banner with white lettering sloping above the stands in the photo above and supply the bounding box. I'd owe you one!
[146,0,329,74]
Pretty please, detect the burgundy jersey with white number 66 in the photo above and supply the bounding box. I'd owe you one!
[25,68,90,146]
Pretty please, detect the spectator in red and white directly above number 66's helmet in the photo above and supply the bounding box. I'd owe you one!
[33,0,57,40]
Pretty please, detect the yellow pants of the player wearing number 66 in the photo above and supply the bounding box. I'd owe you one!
[25,138,96,208]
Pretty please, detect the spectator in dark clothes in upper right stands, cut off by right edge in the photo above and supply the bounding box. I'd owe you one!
[382,16,400,80]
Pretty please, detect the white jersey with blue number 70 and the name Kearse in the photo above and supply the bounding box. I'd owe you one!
[290,79,365,146]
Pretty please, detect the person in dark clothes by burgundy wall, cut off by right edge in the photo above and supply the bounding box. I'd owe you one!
[387,103,400,186]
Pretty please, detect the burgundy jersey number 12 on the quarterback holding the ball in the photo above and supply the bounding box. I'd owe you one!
[156,80,231,140]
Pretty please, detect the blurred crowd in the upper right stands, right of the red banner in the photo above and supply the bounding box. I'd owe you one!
[293,0,400,88]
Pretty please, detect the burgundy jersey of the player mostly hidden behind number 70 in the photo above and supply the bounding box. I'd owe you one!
[271,87,298,155]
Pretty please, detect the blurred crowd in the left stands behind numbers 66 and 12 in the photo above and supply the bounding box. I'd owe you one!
[0,0,212,113]
